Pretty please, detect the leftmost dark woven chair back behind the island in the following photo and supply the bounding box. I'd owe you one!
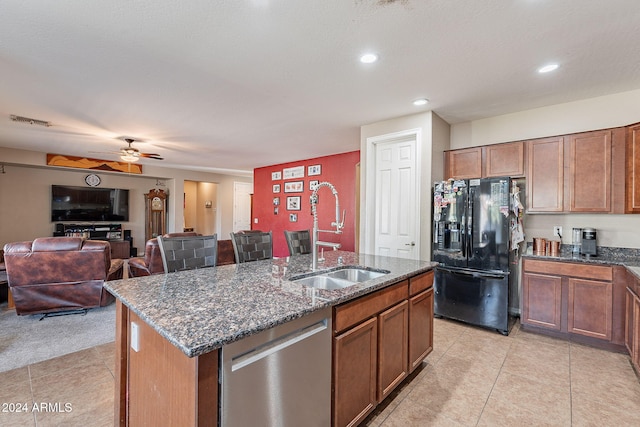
[158,234,218,273]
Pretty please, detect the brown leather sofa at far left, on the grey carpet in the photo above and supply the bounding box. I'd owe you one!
[4,237,123,315]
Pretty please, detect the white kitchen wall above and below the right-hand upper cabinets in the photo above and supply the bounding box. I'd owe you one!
[451,90,640,248]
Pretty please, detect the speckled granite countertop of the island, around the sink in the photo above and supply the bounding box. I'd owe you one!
[104,251,437,357]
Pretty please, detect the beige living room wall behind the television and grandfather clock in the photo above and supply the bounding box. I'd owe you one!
[0,147,253,253]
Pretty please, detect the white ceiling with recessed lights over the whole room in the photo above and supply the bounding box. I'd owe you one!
[0,0,640,172]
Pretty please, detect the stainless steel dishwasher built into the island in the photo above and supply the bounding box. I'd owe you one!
[220,307,331,427]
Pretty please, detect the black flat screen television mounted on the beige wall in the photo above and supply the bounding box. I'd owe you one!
[51,185,129,222]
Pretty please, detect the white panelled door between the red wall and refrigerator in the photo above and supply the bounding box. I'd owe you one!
[373,134,420,259]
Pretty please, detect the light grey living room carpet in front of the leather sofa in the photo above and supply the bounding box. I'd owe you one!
[0,303,116,372]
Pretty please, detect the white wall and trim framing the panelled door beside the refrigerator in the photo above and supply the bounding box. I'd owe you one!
[359,111,450,260]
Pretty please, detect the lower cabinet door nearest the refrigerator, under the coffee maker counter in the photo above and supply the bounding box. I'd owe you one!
[521,273,562,331]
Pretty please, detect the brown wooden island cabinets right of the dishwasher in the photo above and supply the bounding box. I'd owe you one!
[332,271,433,427]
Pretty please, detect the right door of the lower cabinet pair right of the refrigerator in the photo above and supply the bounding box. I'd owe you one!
[567,278,613,341]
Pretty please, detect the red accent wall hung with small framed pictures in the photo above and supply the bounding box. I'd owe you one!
[252,151,360,257]
